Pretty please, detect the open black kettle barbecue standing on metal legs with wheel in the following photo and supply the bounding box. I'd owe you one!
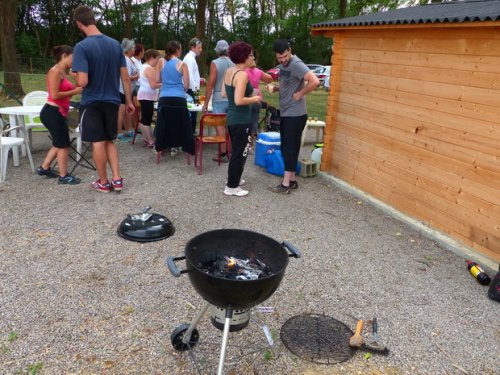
[167,229,301,375]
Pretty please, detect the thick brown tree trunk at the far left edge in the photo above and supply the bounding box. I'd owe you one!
[0,0,24,96]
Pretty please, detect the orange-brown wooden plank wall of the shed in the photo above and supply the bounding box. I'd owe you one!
[321,27,500,261]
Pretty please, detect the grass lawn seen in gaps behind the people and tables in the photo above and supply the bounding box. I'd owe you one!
[0,72,328,120]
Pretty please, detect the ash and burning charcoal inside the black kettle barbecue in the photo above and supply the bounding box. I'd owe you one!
[198,256,272,280]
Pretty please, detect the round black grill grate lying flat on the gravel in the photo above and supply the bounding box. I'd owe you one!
[280,314,354,364]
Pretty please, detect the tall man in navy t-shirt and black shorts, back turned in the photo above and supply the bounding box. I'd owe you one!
[72,5,134,193]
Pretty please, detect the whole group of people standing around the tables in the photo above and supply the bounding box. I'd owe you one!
[37,6,319,197]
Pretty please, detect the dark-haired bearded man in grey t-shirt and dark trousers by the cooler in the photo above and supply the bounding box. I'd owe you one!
[268,39,319,194]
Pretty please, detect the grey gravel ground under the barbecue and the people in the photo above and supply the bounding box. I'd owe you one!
[0,133,500,375]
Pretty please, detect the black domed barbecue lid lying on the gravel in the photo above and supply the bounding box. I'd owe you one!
[117,207,175,242]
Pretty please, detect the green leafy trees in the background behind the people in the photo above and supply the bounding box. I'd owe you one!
[9,0,412,72]
